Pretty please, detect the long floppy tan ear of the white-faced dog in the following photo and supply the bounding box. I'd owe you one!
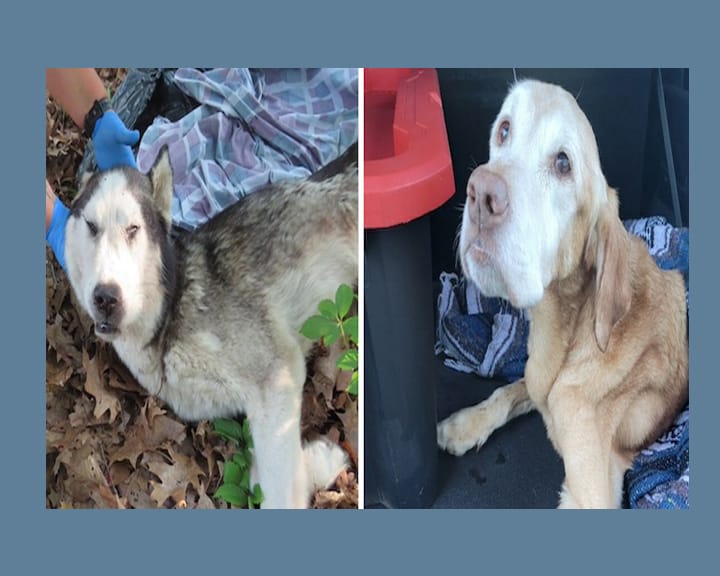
[585,188,632,352]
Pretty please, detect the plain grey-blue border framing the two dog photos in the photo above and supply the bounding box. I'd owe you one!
[0,0,719,574]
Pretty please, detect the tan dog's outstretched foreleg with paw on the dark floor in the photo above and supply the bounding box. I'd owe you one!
[437,379,534,456]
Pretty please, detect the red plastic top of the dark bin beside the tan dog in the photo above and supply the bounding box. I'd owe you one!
[364,68,455,229]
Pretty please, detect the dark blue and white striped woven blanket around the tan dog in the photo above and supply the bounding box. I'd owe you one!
[435,216,690,508]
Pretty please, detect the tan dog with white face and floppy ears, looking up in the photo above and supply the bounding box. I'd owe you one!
[437,80,688,508]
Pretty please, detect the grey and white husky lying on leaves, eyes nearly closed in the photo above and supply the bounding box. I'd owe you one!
[66,145,358,508]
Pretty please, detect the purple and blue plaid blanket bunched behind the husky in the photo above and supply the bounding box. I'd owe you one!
[137,68,358,228]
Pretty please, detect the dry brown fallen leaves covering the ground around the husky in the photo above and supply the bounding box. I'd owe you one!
[46,69,358,508]
